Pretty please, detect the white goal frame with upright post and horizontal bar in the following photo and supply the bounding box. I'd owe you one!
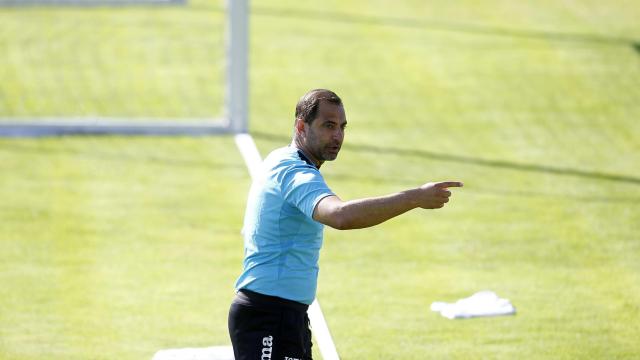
[0,0,249,137]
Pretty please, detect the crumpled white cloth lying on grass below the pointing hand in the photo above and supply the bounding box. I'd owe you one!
[431,290,516,319]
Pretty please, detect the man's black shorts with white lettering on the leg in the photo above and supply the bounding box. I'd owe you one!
[229,290,311,360]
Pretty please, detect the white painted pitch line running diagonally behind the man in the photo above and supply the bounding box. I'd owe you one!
[235,134,340,360]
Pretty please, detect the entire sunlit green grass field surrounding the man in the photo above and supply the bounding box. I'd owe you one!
[0,0,640,359]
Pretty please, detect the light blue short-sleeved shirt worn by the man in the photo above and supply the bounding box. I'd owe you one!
[236,146,334,304]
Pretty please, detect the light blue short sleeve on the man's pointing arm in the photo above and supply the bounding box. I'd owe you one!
[282,166,334,218]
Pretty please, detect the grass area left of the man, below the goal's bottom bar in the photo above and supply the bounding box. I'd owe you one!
[0,138,248,359]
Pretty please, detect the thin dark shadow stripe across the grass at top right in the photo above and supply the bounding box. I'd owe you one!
[251,6,640,51]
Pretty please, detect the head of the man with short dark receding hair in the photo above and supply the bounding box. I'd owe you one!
[293,89,347,166]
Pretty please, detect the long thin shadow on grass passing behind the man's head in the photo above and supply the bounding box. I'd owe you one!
[253,132,640,185]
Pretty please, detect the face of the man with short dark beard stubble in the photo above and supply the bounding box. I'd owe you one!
[304,101,347,163]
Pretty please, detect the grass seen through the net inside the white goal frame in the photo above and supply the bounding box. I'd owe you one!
[0,4,225,119]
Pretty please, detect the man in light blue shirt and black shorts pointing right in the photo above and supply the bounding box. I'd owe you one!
[229,89,462,360]
